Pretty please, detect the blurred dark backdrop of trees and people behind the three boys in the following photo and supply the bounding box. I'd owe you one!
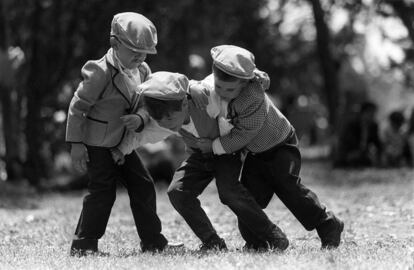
[0,0,414,189]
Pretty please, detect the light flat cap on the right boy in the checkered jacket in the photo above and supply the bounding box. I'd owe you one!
[211,45,256,79]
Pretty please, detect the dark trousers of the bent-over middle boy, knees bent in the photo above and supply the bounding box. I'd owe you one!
[168,153,276,242]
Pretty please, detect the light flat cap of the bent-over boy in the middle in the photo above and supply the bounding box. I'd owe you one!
[139,71,189,100]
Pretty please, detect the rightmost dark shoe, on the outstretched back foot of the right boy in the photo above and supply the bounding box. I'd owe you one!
[316,214,344,249]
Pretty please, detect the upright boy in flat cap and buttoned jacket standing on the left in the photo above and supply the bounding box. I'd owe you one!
[66,12,177,255]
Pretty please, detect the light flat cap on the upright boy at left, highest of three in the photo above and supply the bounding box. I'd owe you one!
[111,12,158,54]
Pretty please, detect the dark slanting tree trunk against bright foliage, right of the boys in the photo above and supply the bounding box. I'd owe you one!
[309,0,339,130]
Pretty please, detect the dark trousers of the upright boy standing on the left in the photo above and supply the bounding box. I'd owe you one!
[74,146,167,248]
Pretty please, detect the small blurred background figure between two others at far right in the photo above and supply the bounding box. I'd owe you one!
[383,111,410,167]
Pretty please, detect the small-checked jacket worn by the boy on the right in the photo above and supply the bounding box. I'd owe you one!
[220,80,293,153]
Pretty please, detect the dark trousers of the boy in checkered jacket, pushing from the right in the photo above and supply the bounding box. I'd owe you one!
[239,134,333,247]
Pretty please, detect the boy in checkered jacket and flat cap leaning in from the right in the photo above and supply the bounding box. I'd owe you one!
[191,45,344,248]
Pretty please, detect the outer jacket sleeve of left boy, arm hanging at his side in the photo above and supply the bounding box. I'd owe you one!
[66,61,107,143]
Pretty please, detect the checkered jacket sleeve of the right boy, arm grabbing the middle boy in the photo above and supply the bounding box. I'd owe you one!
[216,88,266,153]
